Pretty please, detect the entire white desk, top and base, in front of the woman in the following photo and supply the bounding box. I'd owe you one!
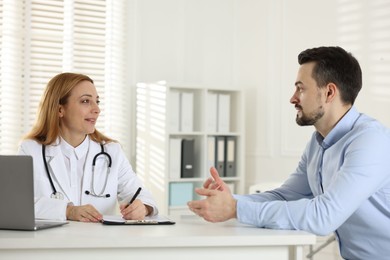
[0,216,316,260]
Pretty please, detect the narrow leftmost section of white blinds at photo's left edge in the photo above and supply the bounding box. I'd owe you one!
[0,0,24,153]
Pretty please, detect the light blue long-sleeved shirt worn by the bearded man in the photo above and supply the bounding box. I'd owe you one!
[235,107,390,259]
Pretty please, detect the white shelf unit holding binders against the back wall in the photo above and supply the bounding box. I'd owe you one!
[136,83,245,215]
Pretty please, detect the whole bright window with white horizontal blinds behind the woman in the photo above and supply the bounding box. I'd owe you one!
[0,0,131,154]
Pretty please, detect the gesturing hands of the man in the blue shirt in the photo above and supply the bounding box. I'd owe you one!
[187,168,237,222]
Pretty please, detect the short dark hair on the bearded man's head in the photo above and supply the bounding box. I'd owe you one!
[298,46,362,105]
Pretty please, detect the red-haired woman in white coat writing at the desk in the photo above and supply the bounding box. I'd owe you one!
[19,73,157,222]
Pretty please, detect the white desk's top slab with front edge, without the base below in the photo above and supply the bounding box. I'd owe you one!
[0,216,316,250]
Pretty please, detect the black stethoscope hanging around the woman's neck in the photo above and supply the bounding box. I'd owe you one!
[42,144,112,200]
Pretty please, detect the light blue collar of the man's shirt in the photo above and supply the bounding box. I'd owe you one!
[316,106,360,149]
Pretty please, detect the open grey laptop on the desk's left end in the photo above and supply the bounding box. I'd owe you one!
[0,155,68,230]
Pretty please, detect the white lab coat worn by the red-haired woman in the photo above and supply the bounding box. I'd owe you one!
[19,137,158,220]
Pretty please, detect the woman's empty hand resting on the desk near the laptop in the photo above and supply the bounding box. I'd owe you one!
[66,204,103,222]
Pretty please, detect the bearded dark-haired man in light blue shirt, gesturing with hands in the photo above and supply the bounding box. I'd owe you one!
[188,47,390,260]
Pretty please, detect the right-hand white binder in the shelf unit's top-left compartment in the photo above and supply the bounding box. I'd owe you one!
[180,92,194,132]
